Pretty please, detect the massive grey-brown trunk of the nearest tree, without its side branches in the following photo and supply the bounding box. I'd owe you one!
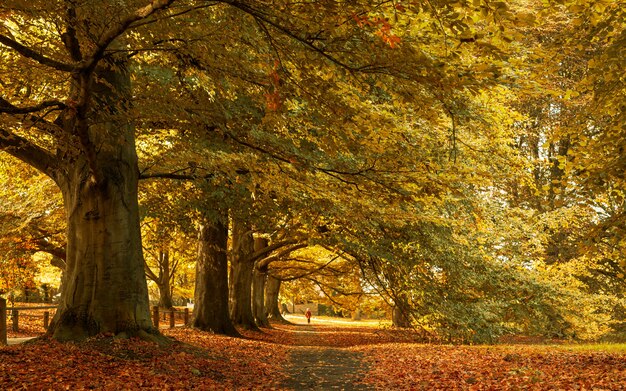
[50,59,155,340]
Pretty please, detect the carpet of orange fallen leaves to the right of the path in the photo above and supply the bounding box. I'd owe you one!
[354,344,626,390]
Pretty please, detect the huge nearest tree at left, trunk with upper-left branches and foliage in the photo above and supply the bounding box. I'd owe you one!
[0,1,177,340]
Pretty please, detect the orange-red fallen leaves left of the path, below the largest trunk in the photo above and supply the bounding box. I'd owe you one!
[0,328,287,390]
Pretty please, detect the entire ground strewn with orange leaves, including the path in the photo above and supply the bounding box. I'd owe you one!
[0,318,626,390]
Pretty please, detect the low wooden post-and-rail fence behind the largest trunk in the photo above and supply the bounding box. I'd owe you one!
[0,297,189,345]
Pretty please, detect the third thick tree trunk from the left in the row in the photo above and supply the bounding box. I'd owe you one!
[230,219,258,330]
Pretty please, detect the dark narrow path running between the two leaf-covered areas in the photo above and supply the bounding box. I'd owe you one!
[282,326,373,390]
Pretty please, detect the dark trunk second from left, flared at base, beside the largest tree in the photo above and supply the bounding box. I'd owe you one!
[192,216,239,336]
